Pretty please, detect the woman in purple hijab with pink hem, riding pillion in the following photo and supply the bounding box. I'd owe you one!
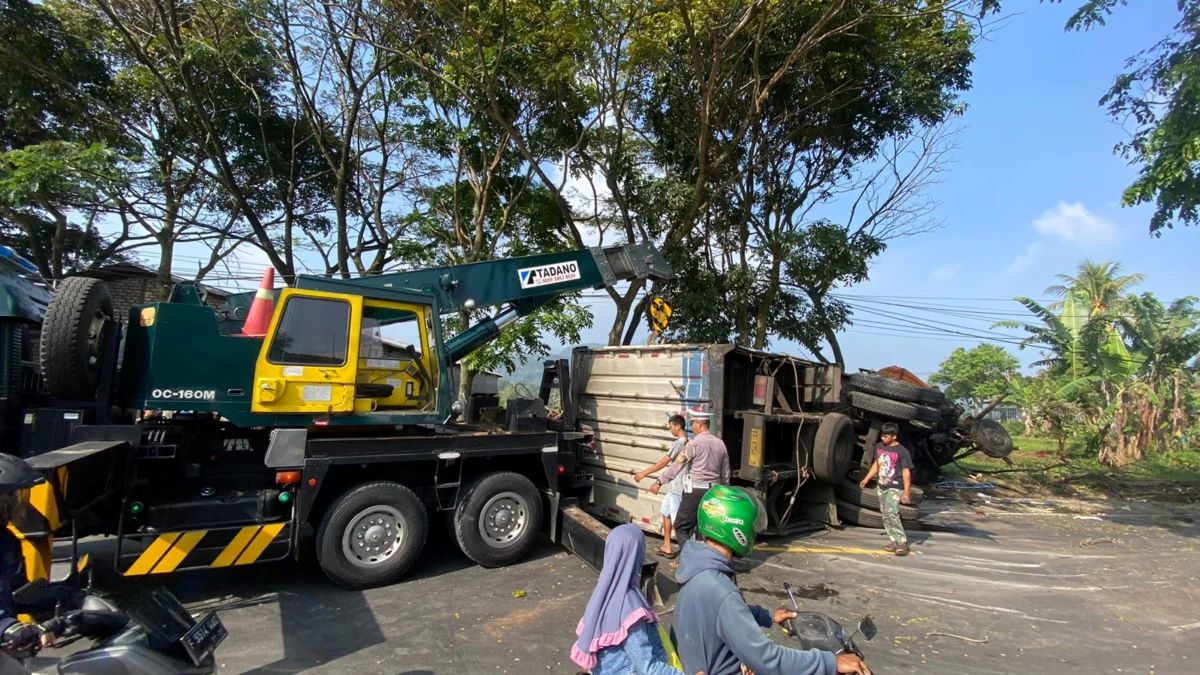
[571,525,683,675]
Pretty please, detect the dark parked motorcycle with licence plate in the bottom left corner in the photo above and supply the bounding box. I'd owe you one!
[0,564,228,675]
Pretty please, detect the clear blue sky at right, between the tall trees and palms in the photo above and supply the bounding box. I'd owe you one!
[825,0,1200,375]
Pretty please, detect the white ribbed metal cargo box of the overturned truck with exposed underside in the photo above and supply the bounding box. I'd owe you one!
[571,345,854,533]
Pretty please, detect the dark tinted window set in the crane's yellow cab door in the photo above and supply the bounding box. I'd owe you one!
[266,297,350,365]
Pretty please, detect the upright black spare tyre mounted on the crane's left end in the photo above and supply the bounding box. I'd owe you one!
[38,276,113,399]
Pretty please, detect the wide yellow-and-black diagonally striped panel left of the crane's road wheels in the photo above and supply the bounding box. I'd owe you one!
[114,522,294,577]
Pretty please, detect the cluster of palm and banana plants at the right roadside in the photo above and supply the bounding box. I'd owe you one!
[1009,263,1200,467]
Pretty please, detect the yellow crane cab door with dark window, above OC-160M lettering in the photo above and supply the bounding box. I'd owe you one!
[251,288,362,414]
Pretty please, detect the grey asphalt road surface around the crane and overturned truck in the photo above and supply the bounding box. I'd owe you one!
[28,492,1200,674]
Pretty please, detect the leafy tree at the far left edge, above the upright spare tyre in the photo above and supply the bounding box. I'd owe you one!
[0,0,133,279]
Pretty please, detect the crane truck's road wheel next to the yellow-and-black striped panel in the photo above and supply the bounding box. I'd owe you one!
[317,482,430,590]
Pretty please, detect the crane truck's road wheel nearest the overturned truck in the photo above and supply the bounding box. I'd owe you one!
[454,471,541,567]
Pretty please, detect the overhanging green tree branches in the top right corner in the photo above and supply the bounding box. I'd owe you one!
[1067,0,1200,237]
